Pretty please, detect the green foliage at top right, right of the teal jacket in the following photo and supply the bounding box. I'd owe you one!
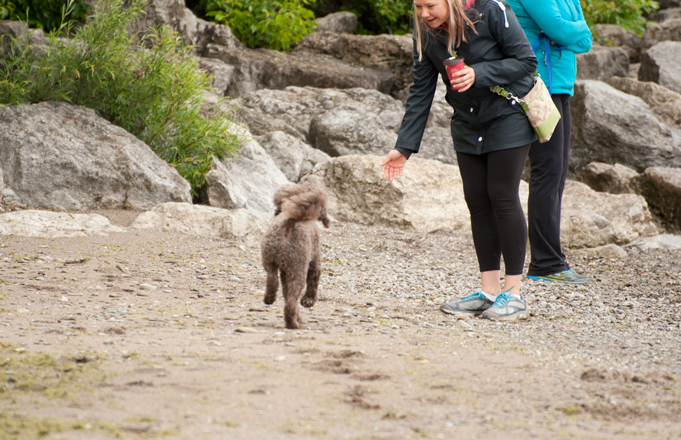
[580,0,659,35]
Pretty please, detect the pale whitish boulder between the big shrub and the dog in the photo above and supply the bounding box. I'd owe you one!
[202,127,289,212]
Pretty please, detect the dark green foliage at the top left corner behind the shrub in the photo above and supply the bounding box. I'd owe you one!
[6,0,89,32]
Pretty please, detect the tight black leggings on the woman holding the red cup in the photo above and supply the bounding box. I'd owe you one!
[456,145,530,275]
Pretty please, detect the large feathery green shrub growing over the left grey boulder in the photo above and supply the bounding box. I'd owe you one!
[0,0,239,195]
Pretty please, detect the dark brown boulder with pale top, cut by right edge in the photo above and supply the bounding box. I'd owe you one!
[639,167,681,232]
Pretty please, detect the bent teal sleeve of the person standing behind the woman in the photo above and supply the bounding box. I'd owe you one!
[520,0,591,45]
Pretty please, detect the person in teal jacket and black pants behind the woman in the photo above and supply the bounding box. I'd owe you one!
[507,0,591,284]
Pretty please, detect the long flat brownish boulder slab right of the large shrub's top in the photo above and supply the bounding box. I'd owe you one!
[202,44,395,98]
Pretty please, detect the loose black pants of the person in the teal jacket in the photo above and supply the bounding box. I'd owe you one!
[527,94,572,276]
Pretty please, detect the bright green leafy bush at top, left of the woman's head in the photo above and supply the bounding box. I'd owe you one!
[195,0,315,51]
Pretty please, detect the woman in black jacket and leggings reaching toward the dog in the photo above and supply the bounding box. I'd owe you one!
[382,0,537,319]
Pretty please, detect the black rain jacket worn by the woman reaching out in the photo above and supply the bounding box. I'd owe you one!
[395,0,537,158]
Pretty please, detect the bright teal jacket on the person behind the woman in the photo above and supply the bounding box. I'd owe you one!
[506,0,591,96]
